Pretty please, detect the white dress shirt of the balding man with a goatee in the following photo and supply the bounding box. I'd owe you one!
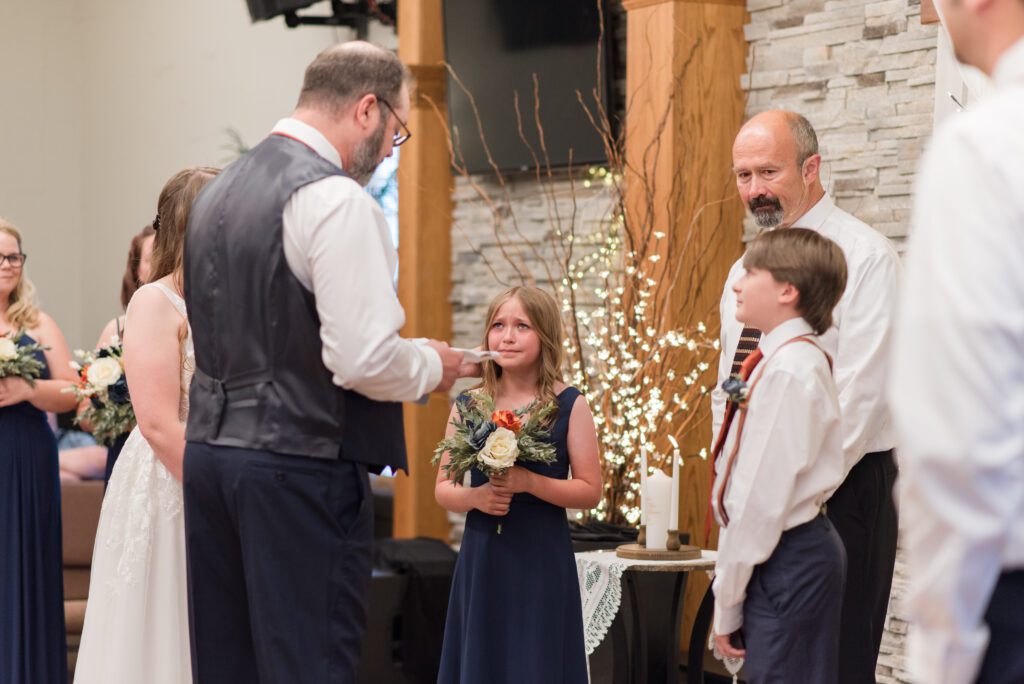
[712,194,901,479]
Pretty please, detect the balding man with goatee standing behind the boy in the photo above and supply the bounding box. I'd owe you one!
[712,111,900,684]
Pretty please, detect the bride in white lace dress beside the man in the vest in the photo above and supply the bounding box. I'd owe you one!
[75,168,218,684]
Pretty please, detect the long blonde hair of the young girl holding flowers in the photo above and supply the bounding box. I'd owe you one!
[480,286,565,411]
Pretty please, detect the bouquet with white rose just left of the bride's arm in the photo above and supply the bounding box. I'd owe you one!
[69,336,135,446]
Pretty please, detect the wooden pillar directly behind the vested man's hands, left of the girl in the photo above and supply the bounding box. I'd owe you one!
[394,0,452,541]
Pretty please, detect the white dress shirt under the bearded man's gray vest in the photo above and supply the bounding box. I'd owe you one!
[272,119,441,401]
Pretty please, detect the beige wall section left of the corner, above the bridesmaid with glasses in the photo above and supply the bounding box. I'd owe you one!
[0,0,87,336]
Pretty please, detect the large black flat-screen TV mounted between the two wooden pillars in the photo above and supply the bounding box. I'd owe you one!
[444,0,611,173]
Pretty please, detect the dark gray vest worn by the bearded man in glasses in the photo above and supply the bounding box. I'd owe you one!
[184,135,406,470]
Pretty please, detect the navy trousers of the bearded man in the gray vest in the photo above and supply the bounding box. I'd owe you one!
[183,442,373,684]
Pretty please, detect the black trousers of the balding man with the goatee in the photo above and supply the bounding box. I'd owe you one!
[828,450,898,684]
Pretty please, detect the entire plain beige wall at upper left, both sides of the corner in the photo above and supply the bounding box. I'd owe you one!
[0,0,393,347]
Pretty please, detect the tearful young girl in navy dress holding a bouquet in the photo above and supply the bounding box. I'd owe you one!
[434,287,601,684]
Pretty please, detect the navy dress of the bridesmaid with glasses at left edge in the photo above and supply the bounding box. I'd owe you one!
[0,335,68,684]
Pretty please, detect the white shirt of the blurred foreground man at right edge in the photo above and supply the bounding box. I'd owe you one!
[890,40,1024,684]
